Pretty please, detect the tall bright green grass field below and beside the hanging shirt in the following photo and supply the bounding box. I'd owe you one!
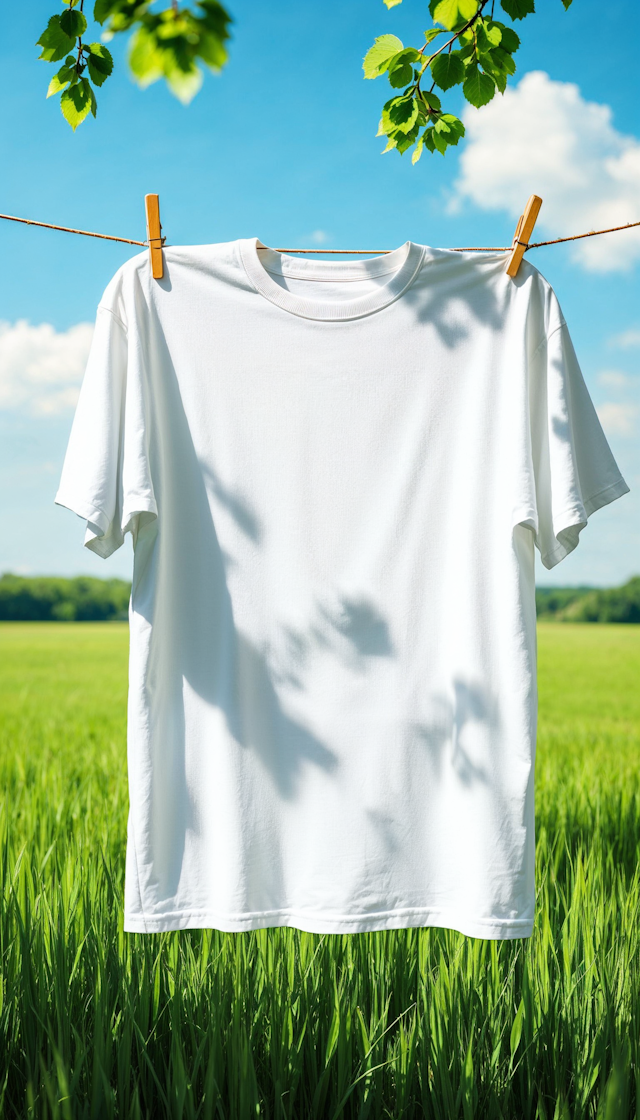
[0,623,640,1120]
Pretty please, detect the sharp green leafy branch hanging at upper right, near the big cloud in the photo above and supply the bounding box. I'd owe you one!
[362,0,572,164]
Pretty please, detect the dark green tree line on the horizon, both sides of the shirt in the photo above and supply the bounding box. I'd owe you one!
[0,572,640,623]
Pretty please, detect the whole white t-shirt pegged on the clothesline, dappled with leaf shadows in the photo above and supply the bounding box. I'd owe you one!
[55,237,629,939]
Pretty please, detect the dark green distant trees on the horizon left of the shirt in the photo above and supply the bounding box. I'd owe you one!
[0,572,131,622]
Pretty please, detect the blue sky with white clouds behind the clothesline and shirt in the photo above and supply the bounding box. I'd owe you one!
[0,0,640,586]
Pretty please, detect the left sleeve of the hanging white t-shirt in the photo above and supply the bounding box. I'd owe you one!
[55,286,158,558]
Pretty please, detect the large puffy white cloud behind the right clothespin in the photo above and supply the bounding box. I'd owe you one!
[449,71,640,272]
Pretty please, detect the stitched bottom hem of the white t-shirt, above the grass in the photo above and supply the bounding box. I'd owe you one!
[123,908,534,941]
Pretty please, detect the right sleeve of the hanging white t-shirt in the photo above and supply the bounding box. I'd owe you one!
[529,292,630,569]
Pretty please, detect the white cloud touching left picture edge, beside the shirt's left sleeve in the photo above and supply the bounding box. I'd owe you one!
[0,319,93,416]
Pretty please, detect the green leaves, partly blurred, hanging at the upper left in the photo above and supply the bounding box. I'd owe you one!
[38,0,232,131]
